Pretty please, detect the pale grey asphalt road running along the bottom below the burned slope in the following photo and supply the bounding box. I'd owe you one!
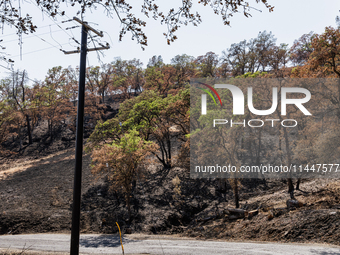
[0,234,340,255]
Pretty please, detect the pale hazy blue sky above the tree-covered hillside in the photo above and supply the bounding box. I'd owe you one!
[0,0,340,80]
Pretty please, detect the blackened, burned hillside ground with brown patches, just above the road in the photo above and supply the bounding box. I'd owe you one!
[0,148,340,245]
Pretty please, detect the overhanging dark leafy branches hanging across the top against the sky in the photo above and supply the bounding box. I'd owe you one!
[0,0,274,55]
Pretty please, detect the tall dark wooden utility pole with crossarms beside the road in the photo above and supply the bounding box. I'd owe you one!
[64,17,110,255]
